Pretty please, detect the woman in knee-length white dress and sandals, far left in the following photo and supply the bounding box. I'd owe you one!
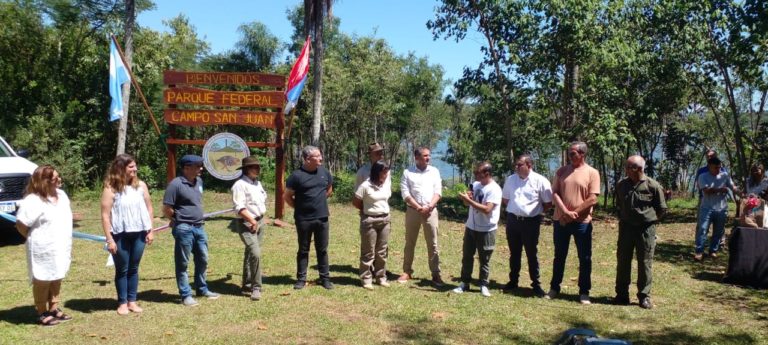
[16,165,72,326]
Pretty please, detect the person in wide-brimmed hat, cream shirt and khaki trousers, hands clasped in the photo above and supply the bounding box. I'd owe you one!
[232,156,267,301]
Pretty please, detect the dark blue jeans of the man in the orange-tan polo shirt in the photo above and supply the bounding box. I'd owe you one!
[549,221,592,295]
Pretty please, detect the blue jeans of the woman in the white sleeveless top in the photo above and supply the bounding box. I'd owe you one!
[112,231,147,304]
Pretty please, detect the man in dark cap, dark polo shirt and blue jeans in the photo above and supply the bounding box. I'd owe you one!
[163,155,219,307]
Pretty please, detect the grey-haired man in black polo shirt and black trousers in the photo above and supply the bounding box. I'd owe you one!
[284,146,333,290]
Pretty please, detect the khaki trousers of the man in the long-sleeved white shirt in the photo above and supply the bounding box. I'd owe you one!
[403,207,440,275]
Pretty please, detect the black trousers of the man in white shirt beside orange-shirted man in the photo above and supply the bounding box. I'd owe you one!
[506,213,541,288]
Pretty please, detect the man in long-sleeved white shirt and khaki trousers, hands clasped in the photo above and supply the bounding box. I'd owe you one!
[397,147,445,287]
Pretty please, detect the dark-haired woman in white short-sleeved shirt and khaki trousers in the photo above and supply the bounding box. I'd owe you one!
[352,161,392,290]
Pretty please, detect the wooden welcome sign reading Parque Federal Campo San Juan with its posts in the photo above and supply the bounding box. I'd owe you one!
[163,71,286,219]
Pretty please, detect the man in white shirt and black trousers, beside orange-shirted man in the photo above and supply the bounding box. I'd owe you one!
[501,154,552,297]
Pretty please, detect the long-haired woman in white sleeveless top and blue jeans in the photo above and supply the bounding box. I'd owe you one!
[101,154,154,315]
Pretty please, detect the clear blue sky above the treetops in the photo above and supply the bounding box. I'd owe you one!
[138,0,483,90]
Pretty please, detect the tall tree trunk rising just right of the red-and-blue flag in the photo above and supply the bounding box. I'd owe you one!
[311,0,325,146]
